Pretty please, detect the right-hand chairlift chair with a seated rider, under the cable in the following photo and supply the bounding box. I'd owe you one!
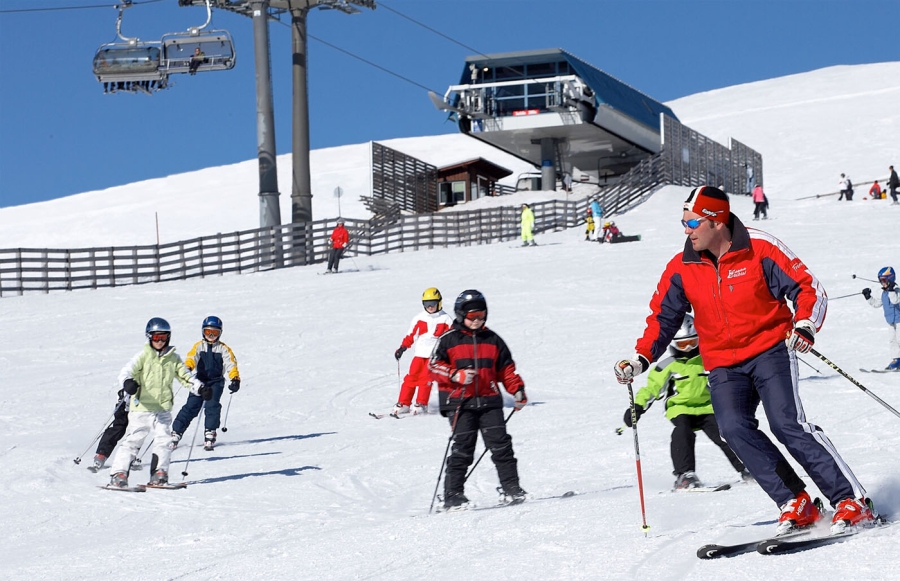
[160,29,236,75]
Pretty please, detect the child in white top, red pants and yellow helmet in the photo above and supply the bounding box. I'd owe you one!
[391,287,453,416]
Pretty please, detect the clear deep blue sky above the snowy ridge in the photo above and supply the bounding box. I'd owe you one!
[0,0,900,208]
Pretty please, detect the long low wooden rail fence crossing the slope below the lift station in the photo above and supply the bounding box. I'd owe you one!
[0,200,587,297]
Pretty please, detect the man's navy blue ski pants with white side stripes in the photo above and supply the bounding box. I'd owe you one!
[709,342,866,507]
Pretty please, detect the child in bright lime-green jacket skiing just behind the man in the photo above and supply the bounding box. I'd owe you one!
[625,315,753,490]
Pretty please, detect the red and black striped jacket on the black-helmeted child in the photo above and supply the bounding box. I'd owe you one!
[428,322,525,415]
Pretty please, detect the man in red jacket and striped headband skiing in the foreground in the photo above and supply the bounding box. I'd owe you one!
[615,186,875,534]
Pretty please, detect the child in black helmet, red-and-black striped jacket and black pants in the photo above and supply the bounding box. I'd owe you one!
[429,290,528,508]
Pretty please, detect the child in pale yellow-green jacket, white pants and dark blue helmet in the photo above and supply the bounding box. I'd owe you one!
[109,317,212,488]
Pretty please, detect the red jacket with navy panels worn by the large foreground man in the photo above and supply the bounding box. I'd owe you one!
[635,215,828,369]
